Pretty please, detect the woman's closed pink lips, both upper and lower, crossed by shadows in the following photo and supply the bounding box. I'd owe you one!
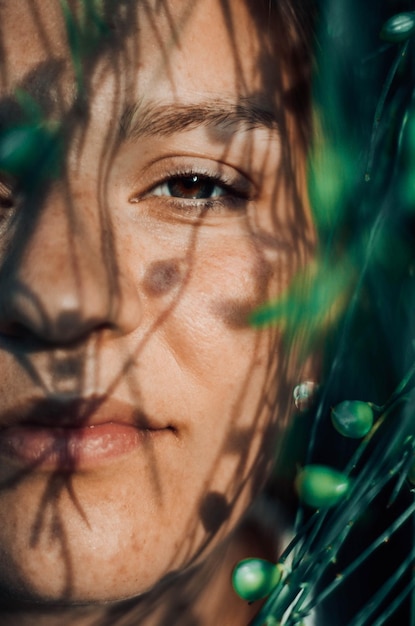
[0,397,173,471]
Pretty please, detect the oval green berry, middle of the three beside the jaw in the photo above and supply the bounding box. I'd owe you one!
[295,465,350,509]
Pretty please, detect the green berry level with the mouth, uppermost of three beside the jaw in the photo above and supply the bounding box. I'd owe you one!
[331,400,373,439]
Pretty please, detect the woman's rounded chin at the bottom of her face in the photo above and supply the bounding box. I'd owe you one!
[0,512,176,605]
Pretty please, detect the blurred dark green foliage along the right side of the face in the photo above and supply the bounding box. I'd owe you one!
[252,0,415,626]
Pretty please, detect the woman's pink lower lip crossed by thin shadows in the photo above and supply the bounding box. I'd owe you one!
[0,422,156,471]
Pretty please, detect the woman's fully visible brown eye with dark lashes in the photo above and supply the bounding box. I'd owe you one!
[133,169,252,214]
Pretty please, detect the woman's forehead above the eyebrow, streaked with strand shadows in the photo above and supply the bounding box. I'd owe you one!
[0,0,281,116]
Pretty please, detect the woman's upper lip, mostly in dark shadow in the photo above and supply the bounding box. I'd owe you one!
[0,395,166,430]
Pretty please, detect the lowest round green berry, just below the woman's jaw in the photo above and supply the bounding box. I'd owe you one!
[232,559,282,602]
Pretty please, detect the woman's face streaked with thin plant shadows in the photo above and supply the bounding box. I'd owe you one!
[0,0,310,602]
